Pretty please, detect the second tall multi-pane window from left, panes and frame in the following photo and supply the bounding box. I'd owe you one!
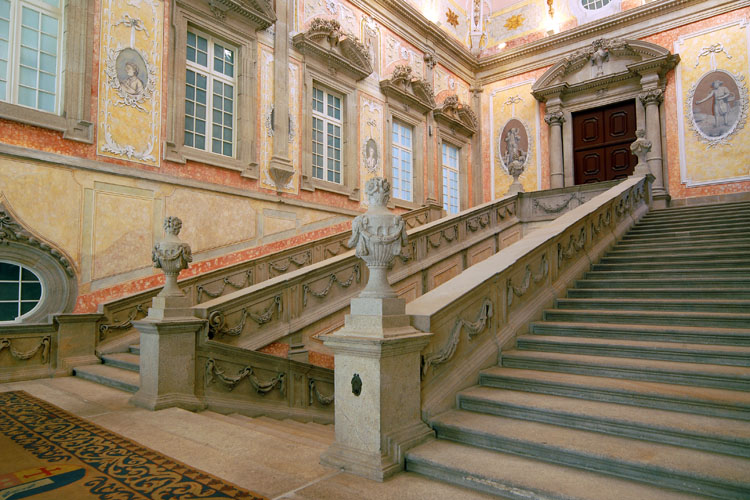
[184,28,236,157]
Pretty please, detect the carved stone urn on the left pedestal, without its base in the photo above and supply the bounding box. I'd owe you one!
[151,216,193,297]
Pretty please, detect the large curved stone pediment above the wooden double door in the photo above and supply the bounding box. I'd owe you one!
[532,38,679,101]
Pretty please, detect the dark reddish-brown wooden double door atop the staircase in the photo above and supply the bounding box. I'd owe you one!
[573,101,638,184]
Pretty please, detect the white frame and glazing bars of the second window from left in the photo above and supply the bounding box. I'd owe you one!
[183,27,239,158]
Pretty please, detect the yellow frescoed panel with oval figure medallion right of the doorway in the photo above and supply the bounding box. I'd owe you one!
[674,19,750,187]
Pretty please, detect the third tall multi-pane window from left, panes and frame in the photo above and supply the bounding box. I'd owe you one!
[312,87,343,184]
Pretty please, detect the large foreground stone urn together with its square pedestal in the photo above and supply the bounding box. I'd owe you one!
[321,177,433,481]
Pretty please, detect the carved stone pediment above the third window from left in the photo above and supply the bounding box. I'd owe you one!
[292,18,372,81]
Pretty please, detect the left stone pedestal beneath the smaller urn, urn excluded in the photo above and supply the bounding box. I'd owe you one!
[130,316,205,410]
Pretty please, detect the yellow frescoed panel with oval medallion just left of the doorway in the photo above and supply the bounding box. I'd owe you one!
[485,80,541,198]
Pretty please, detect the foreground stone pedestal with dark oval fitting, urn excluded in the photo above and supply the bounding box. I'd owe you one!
[321,299,433,481]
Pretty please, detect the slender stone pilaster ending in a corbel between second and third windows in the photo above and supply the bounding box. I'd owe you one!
[269,0,294,190]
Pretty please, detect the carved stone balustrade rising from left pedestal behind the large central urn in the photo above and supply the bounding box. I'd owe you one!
[193,180,624,350]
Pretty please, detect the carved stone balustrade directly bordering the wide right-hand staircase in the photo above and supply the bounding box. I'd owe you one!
[406,176,653,419]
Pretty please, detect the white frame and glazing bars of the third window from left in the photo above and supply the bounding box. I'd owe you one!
[310,83,344,185]
